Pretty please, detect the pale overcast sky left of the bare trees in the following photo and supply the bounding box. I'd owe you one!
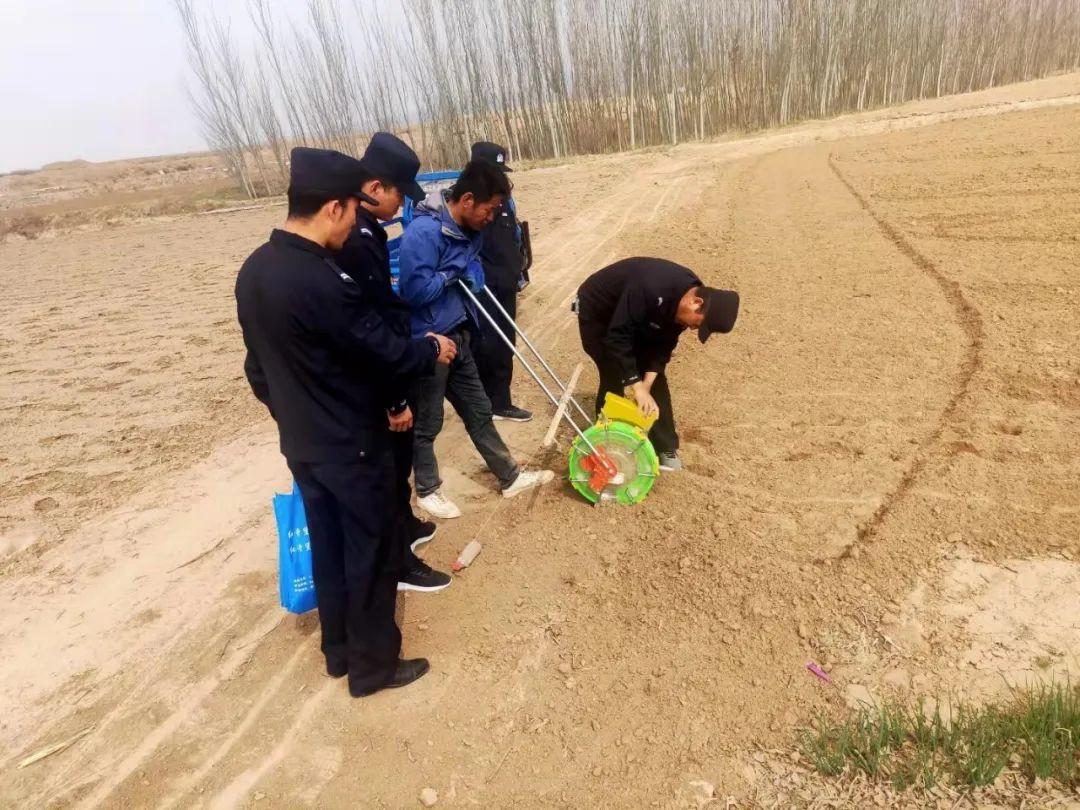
[0,0,253,172]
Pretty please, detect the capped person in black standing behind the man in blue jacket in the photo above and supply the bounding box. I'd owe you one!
[471,140,532,422]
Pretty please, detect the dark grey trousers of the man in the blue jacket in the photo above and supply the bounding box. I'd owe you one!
[413,332,518,498]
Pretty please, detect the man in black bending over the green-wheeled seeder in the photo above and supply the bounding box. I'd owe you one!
[575,257,739,472]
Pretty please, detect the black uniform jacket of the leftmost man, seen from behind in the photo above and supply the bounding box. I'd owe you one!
[237,230,438,462]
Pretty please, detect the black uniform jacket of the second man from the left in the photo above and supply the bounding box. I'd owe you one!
[337,207,413,414]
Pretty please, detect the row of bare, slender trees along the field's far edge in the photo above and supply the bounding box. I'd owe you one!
[174,0,1080,197]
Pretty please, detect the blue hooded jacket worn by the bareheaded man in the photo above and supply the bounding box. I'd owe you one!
[399,191,484,337]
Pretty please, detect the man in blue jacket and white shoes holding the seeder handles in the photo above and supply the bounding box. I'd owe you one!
[400,161,555,518]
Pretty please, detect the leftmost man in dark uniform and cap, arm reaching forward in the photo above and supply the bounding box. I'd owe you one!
[235,148,457,697]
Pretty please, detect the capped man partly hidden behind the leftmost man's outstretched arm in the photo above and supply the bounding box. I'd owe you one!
[337,132,451,592]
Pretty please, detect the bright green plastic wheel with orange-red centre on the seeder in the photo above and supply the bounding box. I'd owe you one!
[569,418,660,505]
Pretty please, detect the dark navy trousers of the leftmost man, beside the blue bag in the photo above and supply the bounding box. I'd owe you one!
[288,449,402,691]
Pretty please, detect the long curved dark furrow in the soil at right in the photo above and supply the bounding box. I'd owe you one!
[828,152,986,542]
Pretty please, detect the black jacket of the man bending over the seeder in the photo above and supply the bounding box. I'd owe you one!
[578,256,702,386]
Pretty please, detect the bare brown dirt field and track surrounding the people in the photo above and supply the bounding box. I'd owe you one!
[0,76,1080,807]
